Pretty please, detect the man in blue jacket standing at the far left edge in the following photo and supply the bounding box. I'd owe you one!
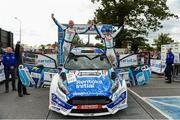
[2,47,16,93]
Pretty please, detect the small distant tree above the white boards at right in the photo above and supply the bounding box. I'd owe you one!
[154,33,174,51]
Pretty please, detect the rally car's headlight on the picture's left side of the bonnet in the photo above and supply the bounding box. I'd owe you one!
[58,72,69,94]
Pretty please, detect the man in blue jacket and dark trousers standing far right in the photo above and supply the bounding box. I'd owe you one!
[165,48,174,83]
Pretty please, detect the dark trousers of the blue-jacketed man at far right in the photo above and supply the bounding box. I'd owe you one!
[165,64,173,82]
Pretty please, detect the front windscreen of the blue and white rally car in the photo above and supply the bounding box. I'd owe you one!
[64,54,111,70]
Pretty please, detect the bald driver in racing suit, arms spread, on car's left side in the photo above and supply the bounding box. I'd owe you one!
[51,14,92,60]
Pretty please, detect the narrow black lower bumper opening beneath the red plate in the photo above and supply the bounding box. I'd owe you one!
[71,108,108,113]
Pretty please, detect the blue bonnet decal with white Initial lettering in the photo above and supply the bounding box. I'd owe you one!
[68,75,111,98]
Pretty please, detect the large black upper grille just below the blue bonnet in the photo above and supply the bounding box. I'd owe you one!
[68,96,112,105]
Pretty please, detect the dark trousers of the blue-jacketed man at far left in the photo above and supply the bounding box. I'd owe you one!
[4,69,16,90]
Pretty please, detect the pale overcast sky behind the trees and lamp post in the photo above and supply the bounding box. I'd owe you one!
[0,0,180,45]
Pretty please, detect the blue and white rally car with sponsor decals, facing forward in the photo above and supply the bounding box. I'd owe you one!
[49,47,127,116]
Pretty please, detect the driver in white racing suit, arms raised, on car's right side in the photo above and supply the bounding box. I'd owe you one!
[94,25,124,67]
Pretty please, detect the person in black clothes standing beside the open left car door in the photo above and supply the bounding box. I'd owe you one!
[15,42,30,97]
